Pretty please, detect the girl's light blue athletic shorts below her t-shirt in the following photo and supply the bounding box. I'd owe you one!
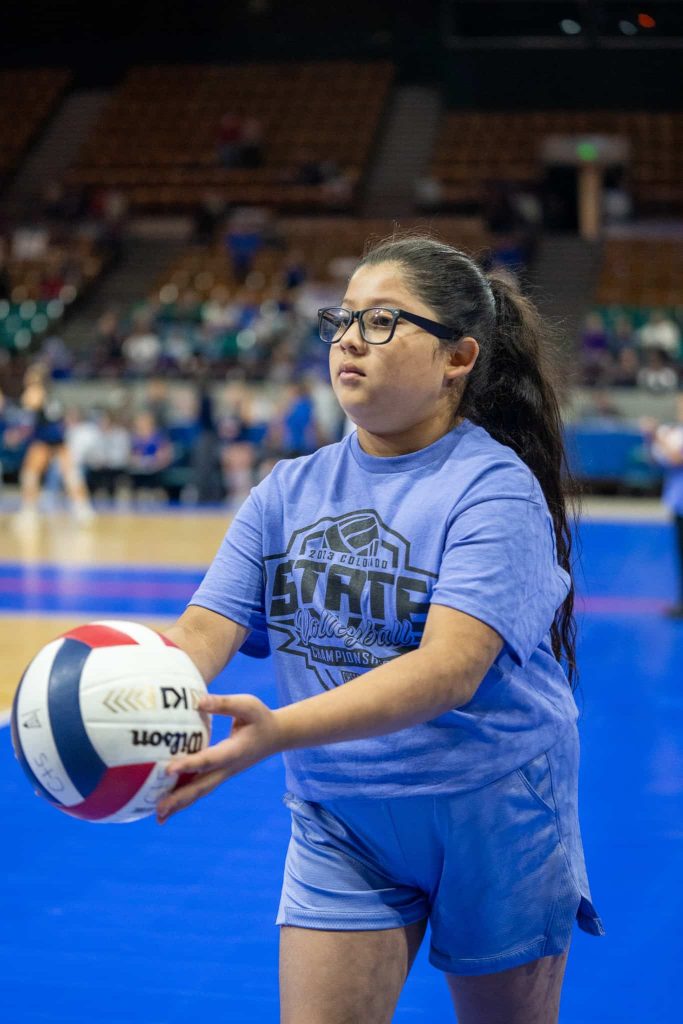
[276,729,604,975]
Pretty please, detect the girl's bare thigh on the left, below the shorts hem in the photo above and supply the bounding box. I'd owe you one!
[280,920,427,1024]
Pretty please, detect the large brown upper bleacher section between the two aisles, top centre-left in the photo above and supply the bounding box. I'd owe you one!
[69,61,393,211]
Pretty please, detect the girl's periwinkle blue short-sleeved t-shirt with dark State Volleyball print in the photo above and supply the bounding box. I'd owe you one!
[190,420,577,801]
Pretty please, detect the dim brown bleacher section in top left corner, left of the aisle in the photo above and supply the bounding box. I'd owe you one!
[0,69,71,182]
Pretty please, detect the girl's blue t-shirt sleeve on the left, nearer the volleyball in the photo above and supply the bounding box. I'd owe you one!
[189,489,269,657]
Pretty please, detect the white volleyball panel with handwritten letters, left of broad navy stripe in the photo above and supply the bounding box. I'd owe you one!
[16,638,83,807]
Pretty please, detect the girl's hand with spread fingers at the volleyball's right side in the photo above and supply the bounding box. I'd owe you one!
[157,693,281,824]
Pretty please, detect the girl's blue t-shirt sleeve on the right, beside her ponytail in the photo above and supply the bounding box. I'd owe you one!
[431,498,569,666]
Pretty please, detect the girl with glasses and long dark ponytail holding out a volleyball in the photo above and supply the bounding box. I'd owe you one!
[159,237,602,1024]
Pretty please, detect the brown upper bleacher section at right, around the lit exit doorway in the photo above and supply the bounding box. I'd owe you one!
[430,111,683,212]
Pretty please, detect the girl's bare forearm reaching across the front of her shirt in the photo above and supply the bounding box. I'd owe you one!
[275,647,495,750]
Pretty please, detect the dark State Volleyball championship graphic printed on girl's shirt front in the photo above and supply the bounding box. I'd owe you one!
[264,509,437,689]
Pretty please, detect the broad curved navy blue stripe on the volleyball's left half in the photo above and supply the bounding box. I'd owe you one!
[47,639,106,799]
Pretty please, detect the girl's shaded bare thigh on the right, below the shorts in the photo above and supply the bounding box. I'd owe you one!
[446,953,567,1024]
